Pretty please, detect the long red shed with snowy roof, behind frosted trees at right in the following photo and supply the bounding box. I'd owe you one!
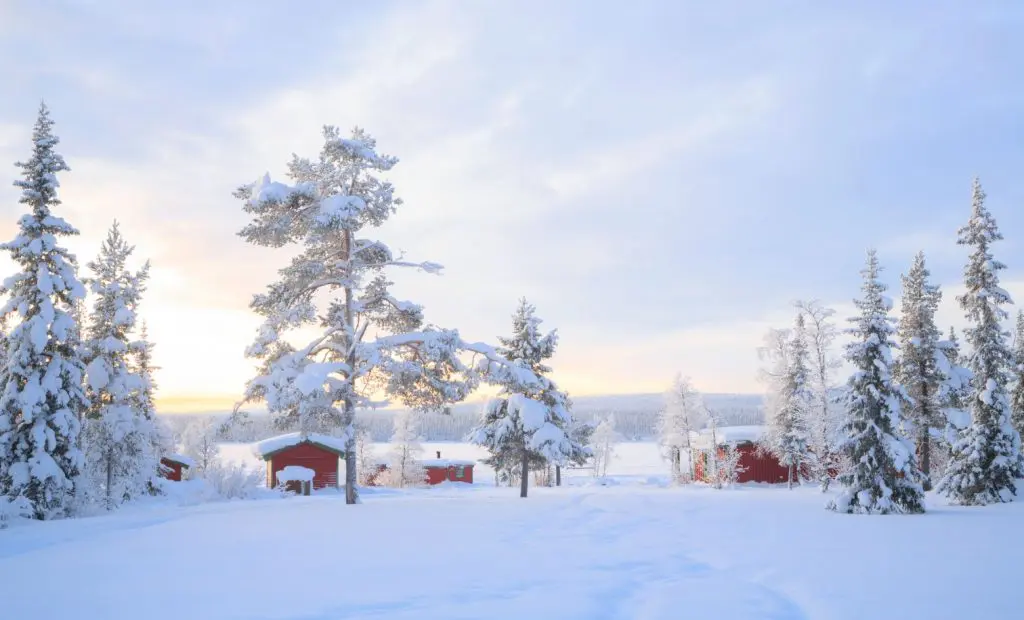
[693,426,790,484]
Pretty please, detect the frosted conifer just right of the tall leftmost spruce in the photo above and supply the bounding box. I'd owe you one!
[82,222,160,508]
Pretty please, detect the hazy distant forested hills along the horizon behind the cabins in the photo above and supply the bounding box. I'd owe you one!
[162,394,764,442]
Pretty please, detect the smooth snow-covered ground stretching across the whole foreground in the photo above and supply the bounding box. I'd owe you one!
[0,444,1024,620]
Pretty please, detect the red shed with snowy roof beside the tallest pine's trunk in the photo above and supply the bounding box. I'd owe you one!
[253,432,345,489]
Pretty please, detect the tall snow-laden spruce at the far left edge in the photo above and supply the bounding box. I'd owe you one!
[0,104,87,519]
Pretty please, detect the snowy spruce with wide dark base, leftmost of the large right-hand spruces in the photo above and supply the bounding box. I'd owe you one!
[828,250,925,514]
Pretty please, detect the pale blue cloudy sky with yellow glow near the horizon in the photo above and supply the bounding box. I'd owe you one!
[0,0,1024,412]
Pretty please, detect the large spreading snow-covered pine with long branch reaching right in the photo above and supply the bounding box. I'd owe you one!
[236,126,561,504]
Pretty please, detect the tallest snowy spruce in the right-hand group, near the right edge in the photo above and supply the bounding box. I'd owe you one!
[939,178,1024,505]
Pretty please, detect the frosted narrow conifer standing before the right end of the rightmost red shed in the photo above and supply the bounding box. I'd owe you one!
[764,313,813,489]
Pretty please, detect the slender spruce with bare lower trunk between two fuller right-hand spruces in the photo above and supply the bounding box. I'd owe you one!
[895,252,946,491]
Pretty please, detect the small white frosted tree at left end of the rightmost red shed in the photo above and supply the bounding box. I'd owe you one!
[657,373,706,482]
